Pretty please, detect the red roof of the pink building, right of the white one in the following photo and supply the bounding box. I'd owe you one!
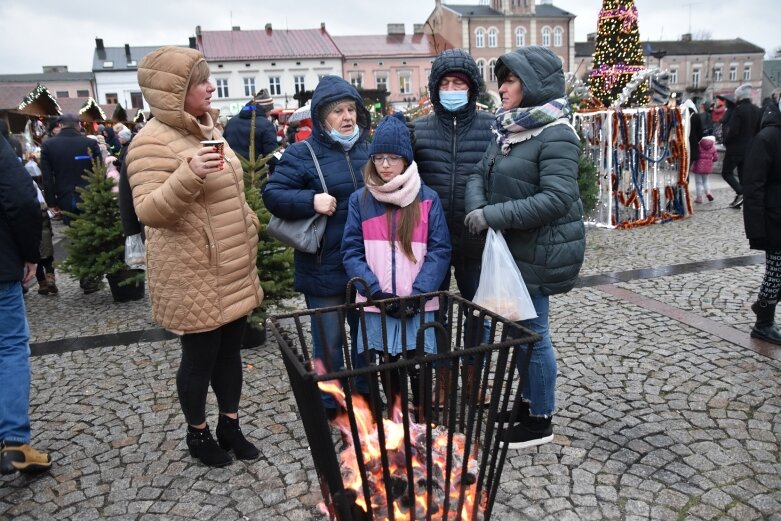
[333,34,437,57]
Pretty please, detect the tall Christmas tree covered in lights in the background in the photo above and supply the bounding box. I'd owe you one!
[588,0,648,107]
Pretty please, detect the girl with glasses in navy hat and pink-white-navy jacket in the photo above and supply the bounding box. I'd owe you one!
[342,116,450,368]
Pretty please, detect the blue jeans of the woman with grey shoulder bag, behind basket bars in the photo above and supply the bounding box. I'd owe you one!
[304,294,369,408]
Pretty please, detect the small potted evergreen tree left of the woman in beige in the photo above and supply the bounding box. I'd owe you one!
[60,158,144,302]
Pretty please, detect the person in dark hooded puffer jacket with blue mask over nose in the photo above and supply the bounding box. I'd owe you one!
[413,49,493,300]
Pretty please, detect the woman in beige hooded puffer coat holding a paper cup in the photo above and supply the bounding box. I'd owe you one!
[127,47,263,466]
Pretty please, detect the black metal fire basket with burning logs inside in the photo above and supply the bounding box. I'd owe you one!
[269,281,539,521]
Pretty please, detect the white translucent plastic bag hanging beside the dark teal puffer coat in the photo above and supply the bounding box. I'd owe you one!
[474,228,537,321]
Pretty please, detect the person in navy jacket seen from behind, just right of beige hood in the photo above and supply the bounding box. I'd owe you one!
[223,89,277,173]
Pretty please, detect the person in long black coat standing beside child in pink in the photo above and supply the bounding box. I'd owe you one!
[721,83,762,208]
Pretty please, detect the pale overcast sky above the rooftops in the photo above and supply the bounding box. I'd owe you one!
[0,0,781,74]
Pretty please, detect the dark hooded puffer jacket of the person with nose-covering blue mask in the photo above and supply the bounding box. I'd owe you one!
[413,49,493,250]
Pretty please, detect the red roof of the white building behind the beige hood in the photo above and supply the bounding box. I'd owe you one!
[198,29,341,61]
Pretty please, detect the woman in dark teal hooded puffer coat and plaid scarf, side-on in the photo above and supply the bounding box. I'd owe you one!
[464,46,586,448]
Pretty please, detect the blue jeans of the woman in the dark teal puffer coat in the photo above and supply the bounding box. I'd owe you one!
[518,295,558,416]
